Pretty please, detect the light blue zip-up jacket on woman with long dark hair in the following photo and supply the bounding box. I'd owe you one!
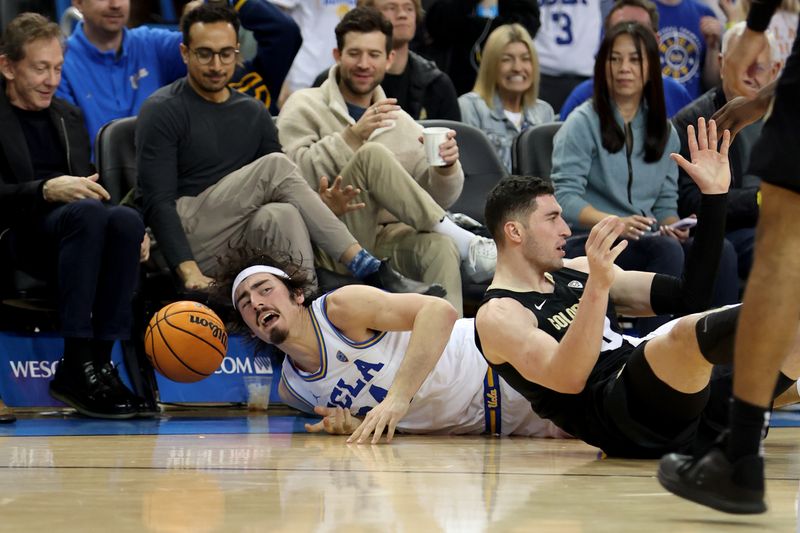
[551,100,680,227]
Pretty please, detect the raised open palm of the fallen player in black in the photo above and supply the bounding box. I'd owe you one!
[670,117,731,194]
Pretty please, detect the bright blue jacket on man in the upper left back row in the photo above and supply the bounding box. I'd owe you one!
[56,22,186,142]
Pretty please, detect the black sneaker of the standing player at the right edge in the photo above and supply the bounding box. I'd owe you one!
[658,447,767,514]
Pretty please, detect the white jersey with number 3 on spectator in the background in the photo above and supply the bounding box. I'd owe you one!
[534,0,603,76]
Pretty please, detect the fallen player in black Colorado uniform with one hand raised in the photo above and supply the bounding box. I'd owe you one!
[476,119,800,466]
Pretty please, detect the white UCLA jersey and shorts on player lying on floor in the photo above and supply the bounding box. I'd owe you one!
[281,296,562,437]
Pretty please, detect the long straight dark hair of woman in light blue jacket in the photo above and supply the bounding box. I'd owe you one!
[593,22,670,163]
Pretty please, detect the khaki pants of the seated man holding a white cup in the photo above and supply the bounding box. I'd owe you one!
[314,143,462,313]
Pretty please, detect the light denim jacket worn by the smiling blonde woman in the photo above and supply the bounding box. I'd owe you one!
[458,92,555,172]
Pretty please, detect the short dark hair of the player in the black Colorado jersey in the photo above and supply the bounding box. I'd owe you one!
[483,176,555,243]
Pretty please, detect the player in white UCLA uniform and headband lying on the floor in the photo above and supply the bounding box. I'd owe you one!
[221,251,567,443]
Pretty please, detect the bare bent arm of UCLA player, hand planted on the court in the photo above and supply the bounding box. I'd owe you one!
[327,285,458,444]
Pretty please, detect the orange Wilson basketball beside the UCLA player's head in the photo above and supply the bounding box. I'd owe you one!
[144,301,228,383]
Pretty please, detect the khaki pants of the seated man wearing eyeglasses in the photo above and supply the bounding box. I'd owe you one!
[176,153,356,279]
